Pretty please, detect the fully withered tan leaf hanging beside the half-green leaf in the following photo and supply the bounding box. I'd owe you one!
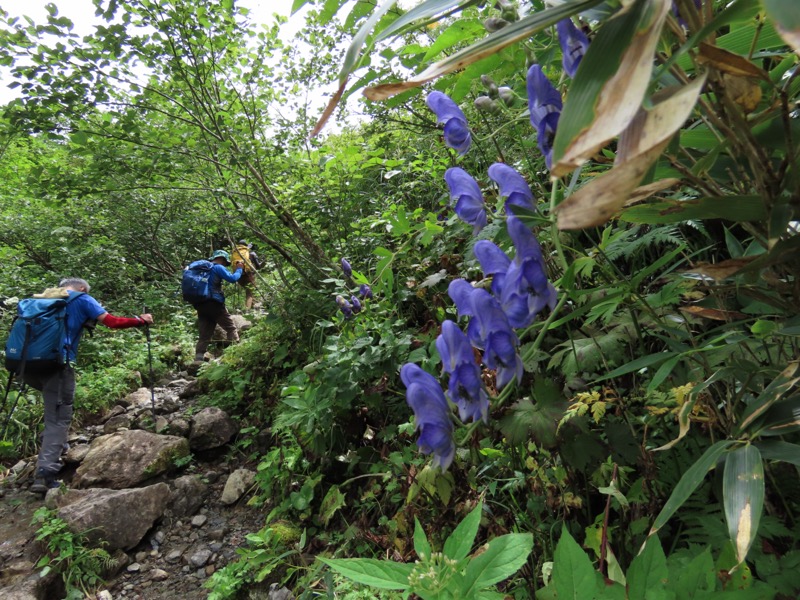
[553,75,705,229]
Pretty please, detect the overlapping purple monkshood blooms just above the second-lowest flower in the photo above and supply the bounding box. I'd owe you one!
[447,279,522,389]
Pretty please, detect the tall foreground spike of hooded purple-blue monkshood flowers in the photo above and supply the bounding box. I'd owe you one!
[400,90,561,470]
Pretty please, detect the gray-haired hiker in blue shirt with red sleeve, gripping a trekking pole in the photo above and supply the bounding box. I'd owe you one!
[23,278,153,493]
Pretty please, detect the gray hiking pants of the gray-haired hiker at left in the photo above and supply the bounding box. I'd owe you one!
[23,367,75,474]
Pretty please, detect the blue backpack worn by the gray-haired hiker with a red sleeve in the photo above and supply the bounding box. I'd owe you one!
[6,292,83,376]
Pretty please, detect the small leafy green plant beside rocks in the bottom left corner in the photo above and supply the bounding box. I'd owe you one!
[33,507,116,598]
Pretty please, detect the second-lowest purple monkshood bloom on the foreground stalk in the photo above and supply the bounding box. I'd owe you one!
[436,320,489,422]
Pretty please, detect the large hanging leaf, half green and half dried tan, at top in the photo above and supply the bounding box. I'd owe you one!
[551,0,671,176]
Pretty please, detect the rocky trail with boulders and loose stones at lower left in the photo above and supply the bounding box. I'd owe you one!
[0,372,290,600]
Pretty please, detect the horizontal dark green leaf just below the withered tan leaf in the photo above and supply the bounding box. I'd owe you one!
[620,196,767,225]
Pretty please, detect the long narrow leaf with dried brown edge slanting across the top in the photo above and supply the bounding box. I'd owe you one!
[364,0,600,100]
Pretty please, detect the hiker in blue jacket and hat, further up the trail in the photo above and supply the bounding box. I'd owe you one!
[194,250,244,362]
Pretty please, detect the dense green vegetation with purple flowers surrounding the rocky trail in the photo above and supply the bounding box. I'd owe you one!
[0,0,800,600]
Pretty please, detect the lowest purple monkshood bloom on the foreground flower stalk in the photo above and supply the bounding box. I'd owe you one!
[400,363,456,471]
